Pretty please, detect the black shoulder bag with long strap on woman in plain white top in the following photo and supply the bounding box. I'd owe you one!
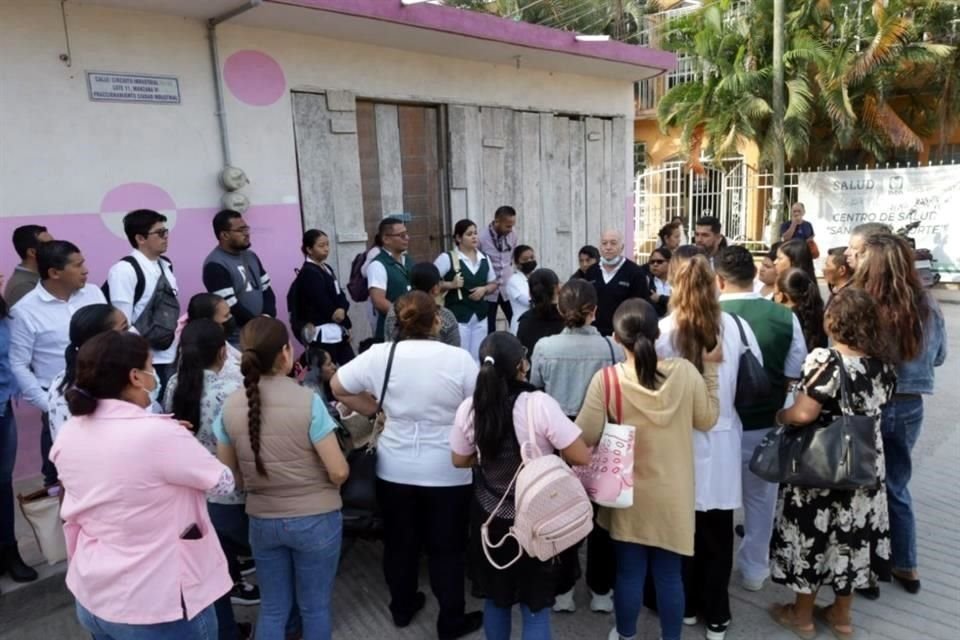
[340,342,397,537]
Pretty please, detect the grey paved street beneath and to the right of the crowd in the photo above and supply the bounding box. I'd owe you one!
[0,300,960,640]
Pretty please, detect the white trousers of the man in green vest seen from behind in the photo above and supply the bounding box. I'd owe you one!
[737,429,777,582]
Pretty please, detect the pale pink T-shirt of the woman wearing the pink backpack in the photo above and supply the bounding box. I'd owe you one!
[450,391,582,456]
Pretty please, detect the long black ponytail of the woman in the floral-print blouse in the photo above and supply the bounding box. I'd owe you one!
[172,319,227,433]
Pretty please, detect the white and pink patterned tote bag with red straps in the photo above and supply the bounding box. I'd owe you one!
[574,367,637,509]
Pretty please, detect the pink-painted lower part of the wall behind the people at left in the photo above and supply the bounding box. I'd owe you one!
[0,201,302,478]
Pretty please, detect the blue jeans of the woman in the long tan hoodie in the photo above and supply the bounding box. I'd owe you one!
[613,540,684,640]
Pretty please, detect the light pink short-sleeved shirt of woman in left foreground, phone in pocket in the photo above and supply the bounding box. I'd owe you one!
[50,400,233,624]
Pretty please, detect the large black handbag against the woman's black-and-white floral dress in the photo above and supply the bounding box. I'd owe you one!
[750,351,877,490]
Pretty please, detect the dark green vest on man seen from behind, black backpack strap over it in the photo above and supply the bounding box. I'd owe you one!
[720,298,793,431]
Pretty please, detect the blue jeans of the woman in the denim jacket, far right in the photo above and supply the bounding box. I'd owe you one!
[880,396,923,571]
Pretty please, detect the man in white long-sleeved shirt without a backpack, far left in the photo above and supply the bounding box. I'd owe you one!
[10,240,106,487]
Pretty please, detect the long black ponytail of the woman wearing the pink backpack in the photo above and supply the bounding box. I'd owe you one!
[473,331,534,460]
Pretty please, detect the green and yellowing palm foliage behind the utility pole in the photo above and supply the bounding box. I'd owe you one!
[657,0,958,167]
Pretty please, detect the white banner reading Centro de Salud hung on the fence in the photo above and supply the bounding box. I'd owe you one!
[799,165,960,282]
